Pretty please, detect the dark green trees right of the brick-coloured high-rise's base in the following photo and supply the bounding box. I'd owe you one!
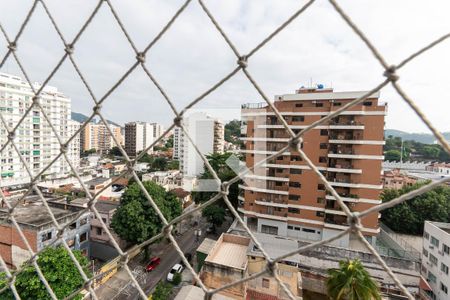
[381,182,450,235]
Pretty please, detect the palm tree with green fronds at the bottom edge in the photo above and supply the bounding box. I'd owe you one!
[327,259,381,300]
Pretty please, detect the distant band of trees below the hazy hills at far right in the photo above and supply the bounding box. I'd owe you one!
[384,136,450,162]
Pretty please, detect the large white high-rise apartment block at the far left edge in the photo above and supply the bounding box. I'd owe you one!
[0,73,80,186]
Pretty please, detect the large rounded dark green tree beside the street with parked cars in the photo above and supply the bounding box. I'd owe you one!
[111,181,182,244]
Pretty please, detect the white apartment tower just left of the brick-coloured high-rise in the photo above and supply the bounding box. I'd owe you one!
[173,112,225,177]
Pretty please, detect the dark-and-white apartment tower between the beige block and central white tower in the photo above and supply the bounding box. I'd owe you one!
[125,122,157,156]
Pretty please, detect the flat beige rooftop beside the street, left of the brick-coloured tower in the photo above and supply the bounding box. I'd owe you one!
[205,233,250,270]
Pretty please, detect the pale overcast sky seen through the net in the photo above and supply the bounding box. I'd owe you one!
[0,0,450,132]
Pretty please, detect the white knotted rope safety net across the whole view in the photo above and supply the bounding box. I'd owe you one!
[0,0,450,299]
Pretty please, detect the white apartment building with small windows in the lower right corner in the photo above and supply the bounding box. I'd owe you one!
[420,221,450,300]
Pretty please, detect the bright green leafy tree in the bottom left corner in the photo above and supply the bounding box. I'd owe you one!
[0,246,91,299]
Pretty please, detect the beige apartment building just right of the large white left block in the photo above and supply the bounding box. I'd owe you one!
[81,123,123,154]
